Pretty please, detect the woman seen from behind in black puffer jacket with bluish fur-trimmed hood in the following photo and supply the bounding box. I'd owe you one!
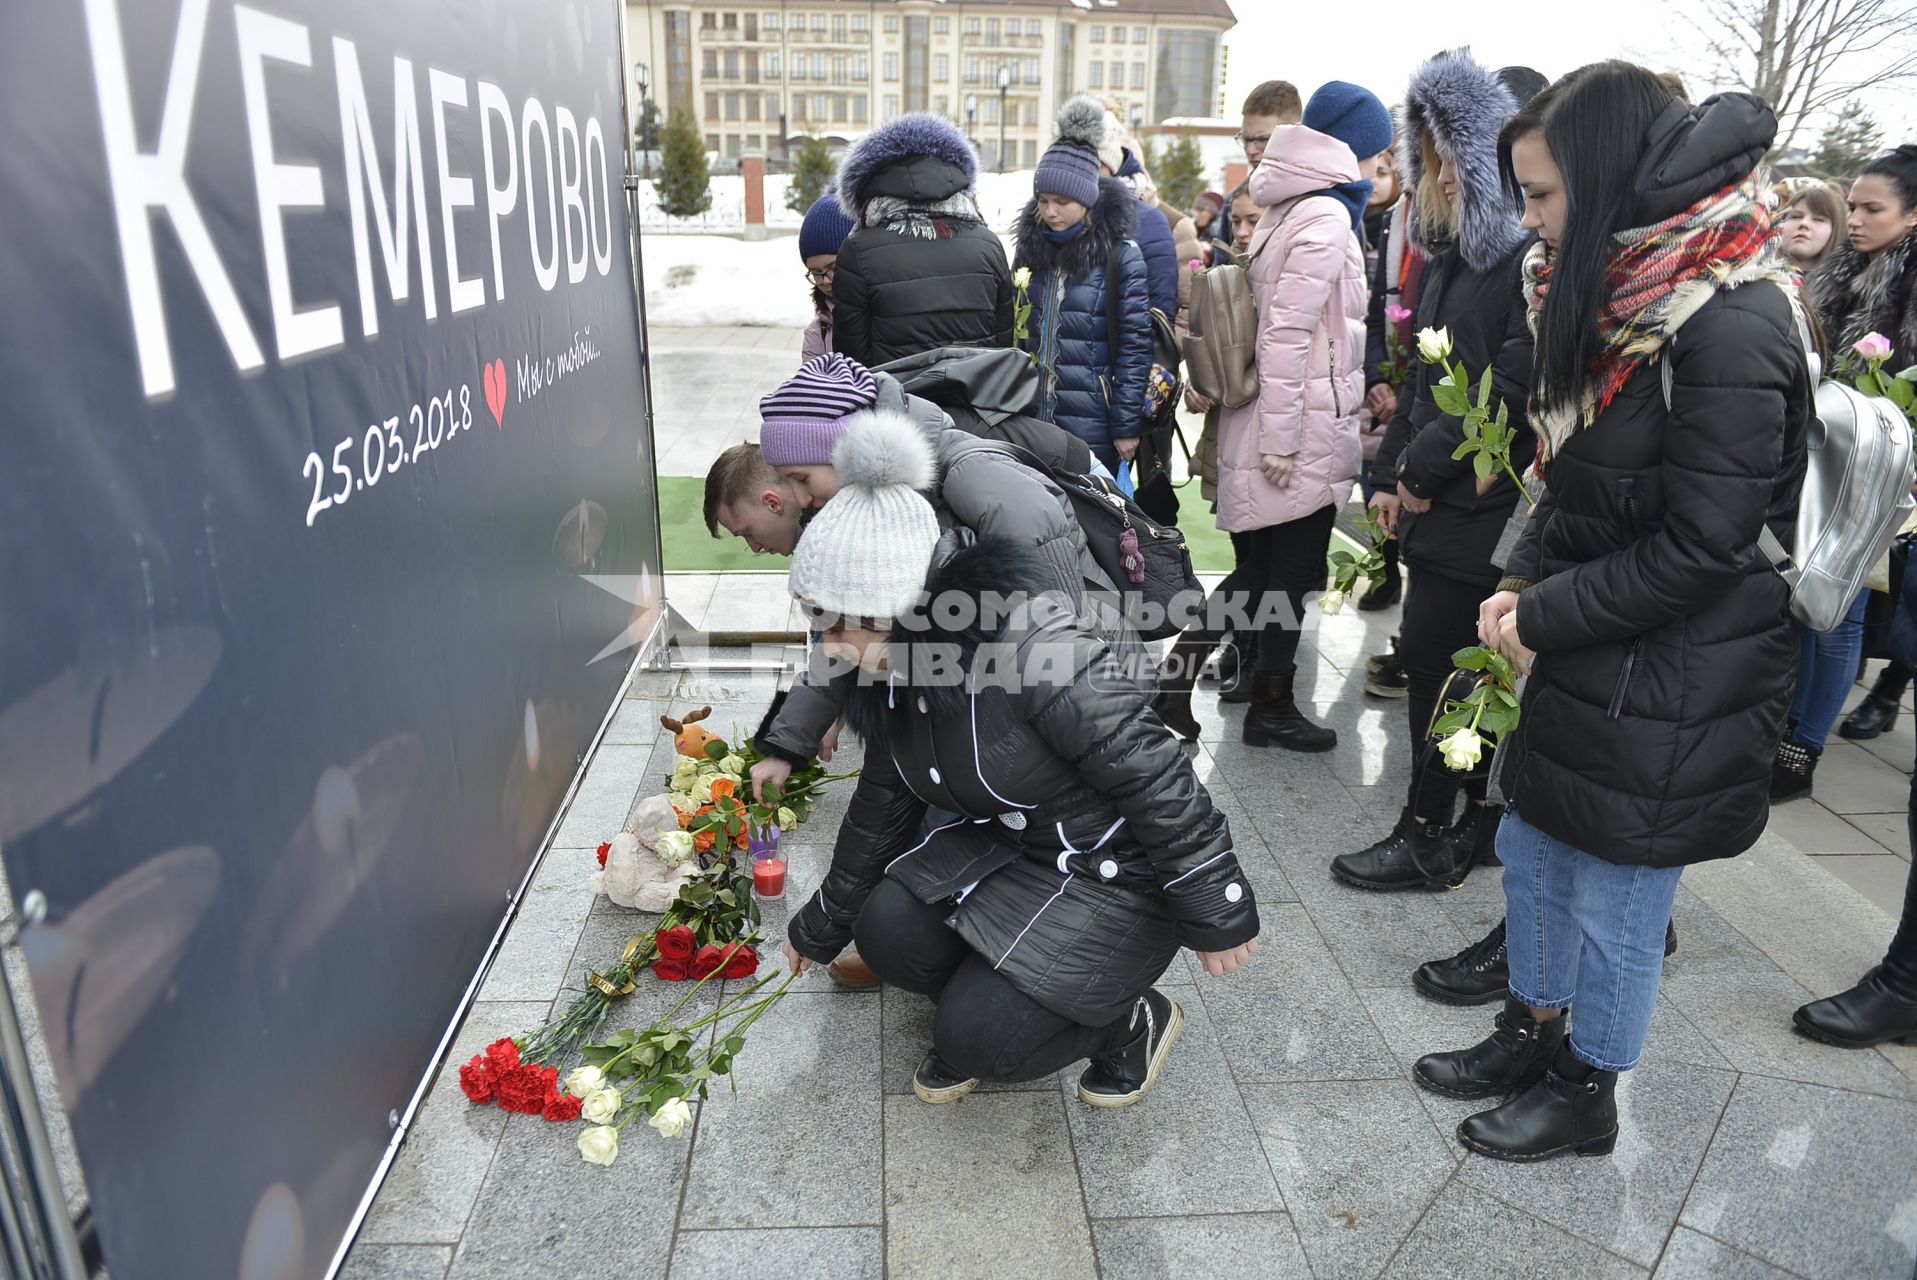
[832,111,1012,368]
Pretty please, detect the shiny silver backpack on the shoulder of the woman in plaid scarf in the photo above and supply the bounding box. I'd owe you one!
[1664,289,1917,630]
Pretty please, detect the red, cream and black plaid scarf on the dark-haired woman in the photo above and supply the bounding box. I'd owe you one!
[1524,174,1796,471]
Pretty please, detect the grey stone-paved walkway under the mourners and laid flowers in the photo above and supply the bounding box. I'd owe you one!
[347,594,1917,1280]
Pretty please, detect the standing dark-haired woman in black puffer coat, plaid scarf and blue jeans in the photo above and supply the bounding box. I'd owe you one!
[1413,72,1812,1161]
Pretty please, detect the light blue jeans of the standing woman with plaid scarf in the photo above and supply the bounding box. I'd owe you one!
[1497,809,1683,1071]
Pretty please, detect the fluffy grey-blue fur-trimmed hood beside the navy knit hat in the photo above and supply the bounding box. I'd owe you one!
[1397,50,1524,270]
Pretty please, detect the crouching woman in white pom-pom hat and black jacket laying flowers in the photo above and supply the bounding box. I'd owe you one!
[786,422,1258,1108]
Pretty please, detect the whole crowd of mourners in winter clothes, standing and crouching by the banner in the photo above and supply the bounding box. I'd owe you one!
[705,50,1917,1161]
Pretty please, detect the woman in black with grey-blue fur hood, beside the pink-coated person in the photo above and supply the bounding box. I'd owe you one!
[1330,50,1536,889]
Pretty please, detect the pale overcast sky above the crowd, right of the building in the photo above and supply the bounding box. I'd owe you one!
[1225,0,1917,144]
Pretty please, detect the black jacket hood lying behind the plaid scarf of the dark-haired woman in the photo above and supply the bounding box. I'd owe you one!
[1631,94,1777,226]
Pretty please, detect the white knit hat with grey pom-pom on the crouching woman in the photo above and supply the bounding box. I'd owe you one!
[786,410,939,625]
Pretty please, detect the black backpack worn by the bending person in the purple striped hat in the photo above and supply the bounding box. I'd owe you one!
[989,441,1204,640]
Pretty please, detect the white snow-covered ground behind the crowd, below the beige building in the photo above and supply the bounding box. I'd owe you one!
[640,169,1031,328]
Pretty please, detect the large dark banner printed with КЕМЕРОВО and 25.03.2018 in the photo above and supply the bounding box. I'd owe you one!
[0,0,659,1280]
